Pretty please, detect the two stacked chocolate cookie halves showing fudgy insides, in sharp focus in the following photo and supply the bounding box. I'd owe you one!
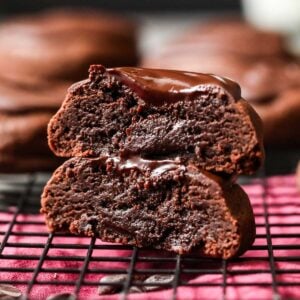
[41,65,264,259]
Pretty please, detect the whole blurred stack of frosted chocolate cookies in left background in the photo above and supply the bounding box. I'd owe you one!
[0,10,138,173]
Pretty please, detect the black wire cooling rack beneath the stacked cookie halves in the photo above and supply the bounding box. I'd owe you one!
[0,170,300,299]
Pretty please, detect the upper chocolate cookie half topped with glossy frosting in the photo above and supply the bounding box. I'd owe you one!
[48,65,263,175]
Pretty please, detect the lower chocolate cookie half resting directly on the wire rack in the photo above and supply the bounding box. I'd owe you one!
[41,157,255,259]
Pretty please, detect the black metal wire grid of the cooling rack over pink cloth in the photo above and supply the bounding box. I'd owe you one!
[0,174,300,300]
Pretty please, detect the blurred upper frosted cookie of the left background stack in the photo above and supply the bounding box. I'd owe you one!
[0,10,137,83]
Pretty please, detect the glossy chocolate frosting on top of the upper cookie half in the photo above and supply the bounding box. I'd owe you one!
[107,67,241,105]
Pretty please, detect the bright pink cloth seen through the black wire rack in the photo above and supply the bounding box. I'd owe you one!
[0,176,300,300]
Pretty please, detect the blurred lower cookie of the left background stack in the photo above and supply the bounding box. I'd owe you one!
[0,80,68,172]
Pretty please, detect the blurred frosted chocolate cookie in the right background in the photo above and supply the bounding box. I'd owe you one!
[142,19,300,146]
